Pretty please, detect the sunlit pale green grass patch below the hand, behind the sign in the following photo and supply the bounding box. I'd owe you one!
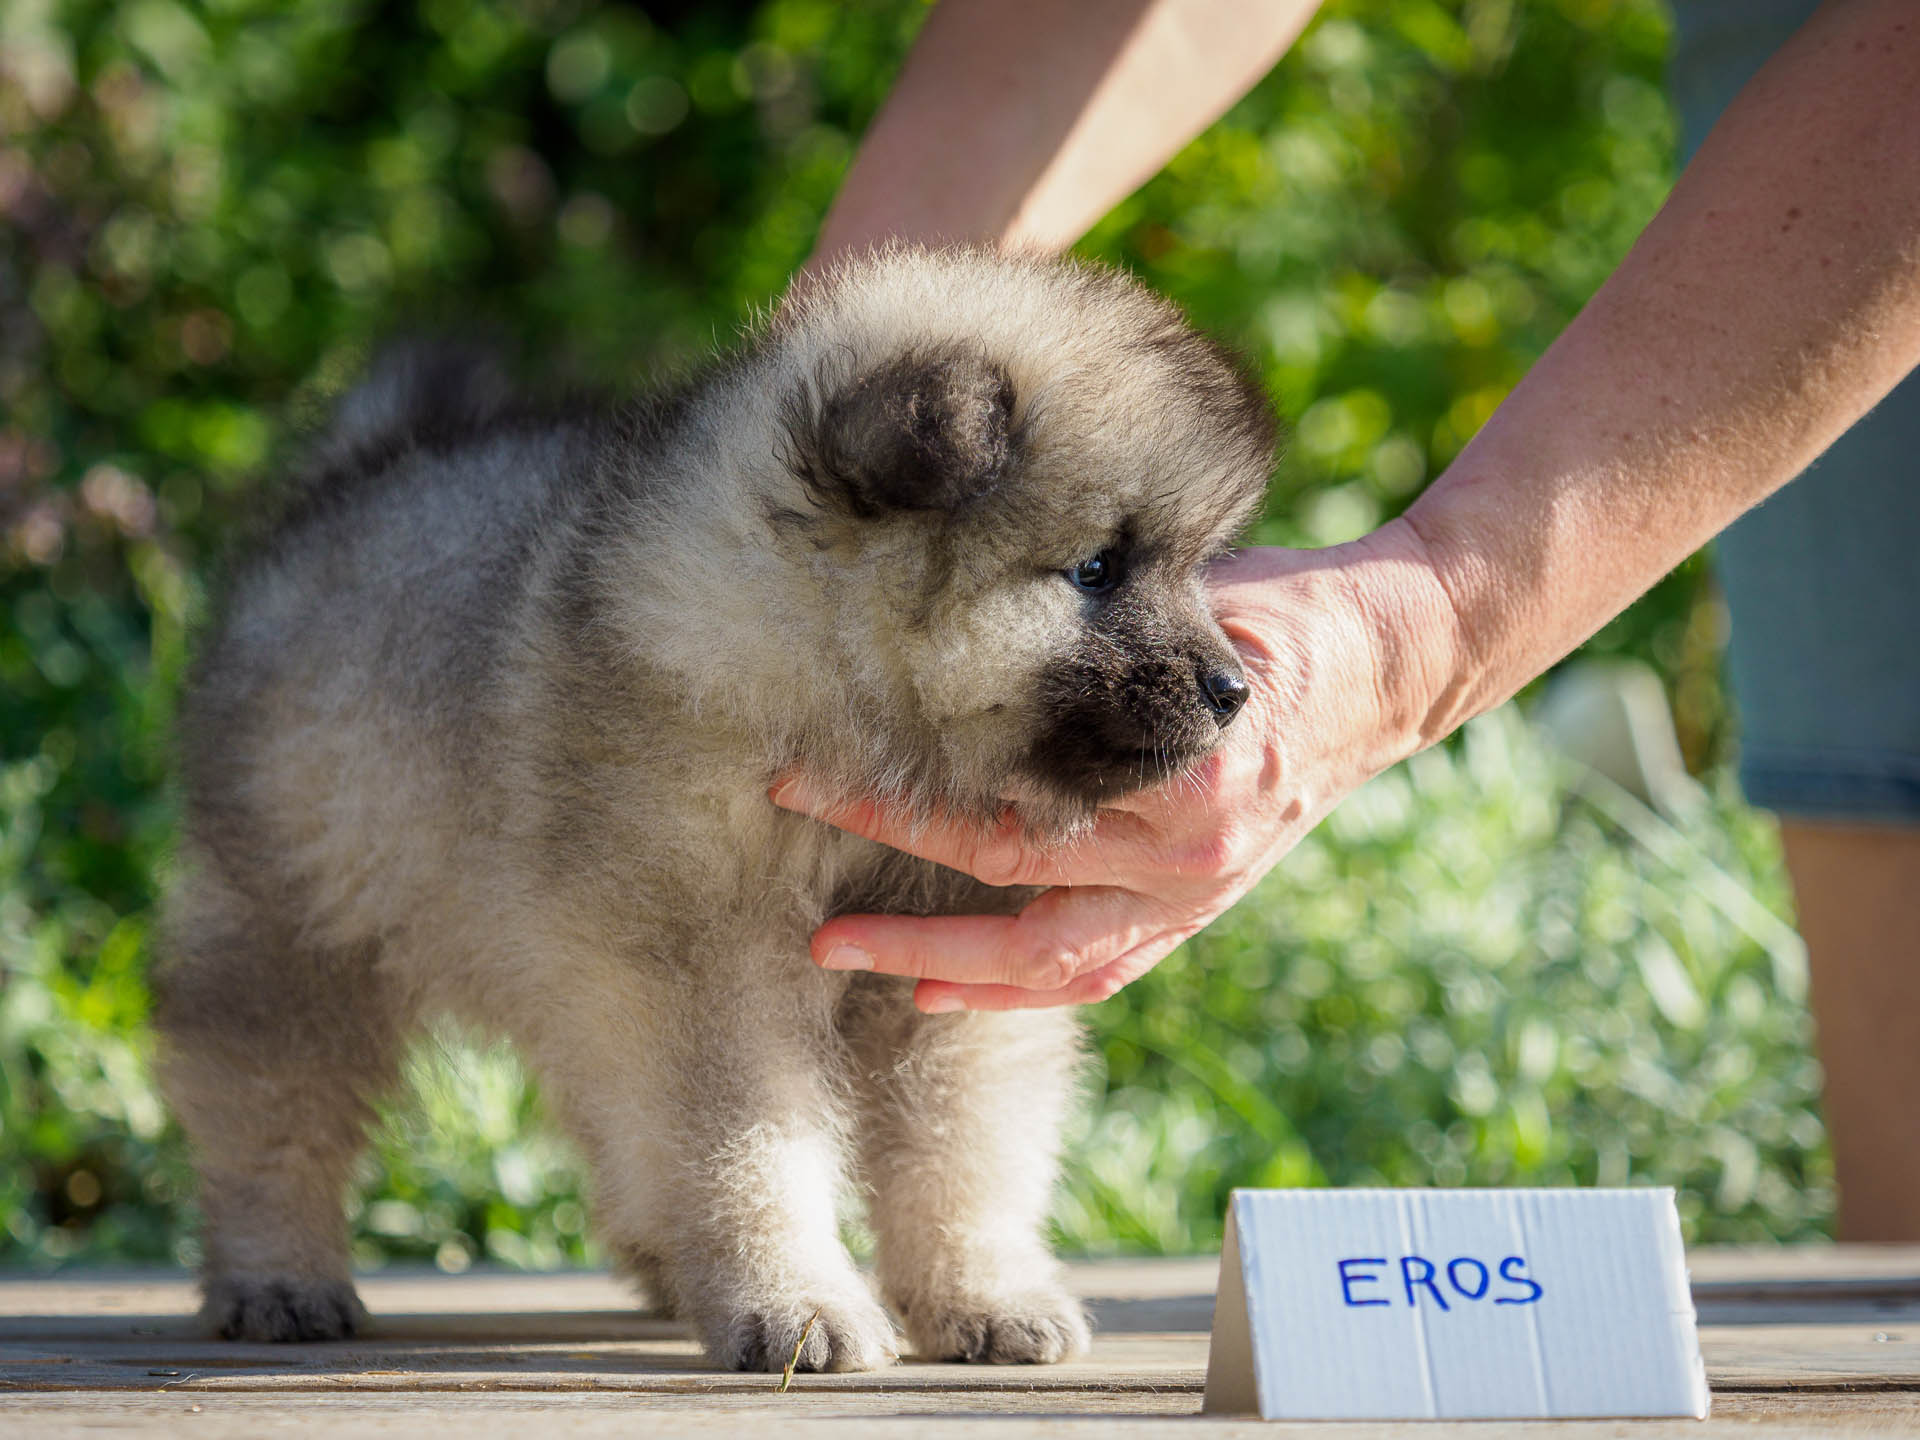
[1062,707,1834,1250]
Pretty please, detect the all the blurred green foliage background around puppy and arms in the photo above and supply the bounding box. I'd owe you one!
[0,0,1832,1267]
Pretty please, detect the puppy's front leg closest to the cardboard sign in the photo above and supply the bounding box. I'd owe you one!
[843,977,1087,1363]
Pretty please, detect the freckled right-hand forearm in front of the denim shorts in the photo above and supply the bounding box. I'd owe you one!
[1407,0,1920,741]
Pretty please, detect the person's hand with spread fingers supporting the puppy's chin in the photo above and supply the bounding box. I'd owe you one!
[772,522,1455,1014]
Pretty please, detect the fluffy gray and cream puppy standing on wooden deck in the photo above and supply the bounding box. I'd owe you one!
[157,248,1273,1369]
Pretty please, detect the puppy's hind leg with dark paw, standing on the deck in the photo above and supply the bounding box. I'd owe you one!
[154,875,401,1340]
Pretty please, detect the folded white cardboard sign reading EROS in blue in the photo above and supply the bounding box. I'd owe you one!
[1206,1188,1709,1421]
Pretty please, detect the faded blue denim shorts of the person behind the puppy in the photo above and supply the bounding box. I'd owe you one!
[1672,0,1920,824]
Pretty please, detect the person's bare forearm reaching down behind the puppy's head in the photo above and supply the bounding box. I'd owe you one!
[814,0,1319,263]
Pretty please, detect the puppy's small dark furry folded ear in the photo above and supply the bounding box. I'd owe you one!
[789,351,1016,516]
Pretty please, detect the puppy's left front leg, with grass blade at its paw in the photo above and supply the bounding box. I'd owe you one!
[514,950,895,1371]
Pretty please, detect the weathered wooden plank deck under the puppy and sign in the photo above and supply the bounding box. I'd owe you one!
[0,1246,1920,1440]
